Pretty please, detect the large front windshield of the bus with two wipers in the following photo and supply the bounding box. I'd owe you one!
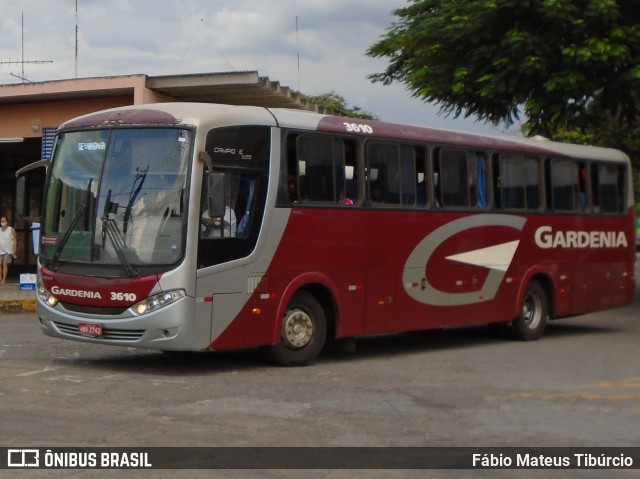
[41,128,192,276]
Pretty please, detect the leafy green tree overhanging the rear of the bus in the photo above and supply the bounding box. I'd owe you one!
[367,0,640,163]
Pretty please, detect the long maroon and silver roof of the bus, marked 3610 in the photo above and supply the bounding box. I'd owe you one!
[60,102,629,163]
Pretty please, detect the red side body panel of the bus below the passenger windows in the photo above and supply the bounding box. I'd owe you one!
[212,208,635,349]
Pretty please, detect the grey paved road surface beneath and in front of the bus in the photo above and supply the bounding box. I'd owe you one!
[0,274,640,478]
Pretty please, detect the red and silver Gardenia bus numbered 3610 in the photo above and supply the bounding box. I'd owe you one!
[37,103,636,366]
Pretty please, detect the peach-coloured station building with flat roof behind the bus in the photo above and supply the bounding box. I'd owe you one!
[0,71,317,275]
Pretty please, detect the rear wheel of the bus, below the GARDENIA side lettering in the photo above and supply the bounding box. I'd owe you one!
[509,281,549,341]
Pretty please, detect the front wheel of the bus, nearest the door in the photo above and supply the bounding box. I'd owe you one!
[267,291,327,366]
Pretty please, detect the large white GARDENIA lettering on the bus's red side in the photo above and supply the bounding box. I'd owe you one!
[535,226,629,249]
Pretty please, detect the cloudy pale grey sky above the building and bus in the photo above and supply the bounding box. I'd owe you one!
[0,0,504,133]
